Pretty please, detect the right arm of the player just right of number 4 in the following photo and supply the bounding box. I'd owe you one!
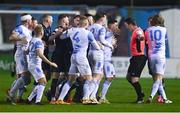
[99,28,113,49]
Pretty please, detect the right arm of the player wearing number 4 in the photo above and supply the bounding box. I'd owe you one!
[88,32,103,50]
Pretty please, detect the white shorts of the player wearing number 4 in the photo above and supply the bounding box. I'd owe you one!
[69,54,92,76]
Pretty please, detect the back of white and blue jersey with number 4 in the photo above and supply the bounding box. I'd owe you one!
[70,28,90,55]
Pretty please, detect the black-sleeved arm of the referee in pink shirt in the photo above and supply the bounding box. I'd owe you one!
[136,31,144,53]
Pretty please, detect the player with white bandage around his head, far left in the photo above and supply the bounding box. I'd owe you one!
[7,14,32,104]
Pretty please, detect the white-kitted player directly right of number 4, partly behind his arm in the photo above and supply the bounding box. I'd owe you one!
[88,14,113,103]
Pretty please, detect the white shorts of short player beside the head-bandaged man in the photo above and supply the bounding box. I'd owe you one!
[28,64,45,82]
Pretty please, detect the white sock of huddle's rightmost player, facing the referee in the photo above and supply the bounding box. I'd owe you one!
[101,80,111,99]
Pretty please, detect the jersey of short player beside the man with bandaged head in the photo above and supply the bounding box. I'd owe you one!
[28,38,44,64]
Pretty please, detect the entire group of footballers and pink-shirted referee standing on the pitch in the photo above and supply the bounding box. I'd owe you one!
[7,13,172,105]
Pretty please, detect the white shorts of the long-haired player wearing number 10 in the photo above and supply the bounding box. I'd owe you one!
[149,57,166,75]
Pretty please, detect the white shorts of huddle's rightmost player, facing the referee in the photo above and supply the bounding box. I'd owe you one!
[104,61,115,78]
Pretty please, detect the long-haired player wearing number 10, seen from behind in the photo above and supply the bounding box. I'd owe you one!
[145,15,172,103]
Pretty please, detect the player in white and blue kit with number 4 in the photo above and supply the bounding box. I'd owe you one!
[56,16,100,104]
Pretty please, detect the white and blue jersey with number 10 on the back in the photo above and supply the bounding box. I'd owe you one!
[145,26,167,57]
